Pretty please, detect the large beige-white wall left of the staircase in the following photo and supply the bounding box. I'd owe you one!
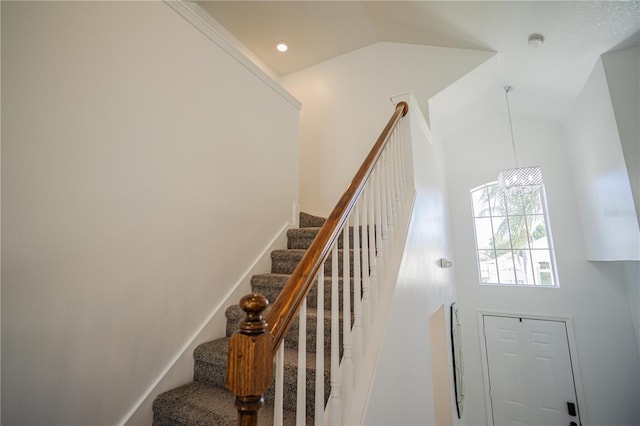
[2,2,298,425]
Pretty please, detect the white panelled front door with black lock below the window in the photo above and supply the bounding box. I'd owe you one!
[483,315,580,426]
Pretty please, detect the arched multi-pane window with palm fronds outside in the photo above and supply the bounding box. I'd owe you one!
[471,182,558,287]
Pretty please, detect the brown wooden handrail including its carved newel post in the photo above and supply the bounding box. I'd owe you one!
[227,102,409,426]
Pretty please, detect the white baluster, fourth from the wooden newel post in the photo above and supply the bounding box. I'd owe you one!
[330,242,342,425]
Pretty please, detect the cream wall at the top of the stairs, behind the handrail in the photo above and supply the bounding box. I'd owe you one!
[281,43,493,215]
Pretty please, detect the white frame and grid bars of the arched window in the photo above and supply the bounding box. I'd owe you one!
[469,181,560,288]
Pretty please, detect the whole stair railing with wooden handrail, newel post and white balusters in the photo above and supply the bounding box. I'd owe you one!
[227,102,414,426]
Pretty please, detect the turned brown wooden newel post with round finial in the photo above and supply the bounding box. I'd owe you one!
[227,294,273,426]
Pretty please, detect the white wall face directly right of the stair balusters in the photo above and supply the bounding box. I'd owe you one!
[365,95,456,426]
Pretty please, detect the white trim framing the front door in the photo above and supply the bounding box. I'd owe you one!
[477,310,590,426]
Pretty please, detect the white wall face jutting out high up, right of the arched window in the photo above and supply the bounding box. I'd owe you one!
[566,61,640,260]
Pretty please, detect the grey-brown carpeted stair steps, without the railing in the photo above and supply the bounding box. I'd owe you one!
[153,213,342,426]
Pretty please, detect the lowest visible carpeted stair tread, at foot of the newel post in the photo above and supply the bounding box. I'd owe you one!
[153,382,313,426]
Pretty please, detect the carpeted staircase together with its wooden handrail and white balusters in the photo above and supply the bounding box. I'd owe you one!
[153,101,415,426]
